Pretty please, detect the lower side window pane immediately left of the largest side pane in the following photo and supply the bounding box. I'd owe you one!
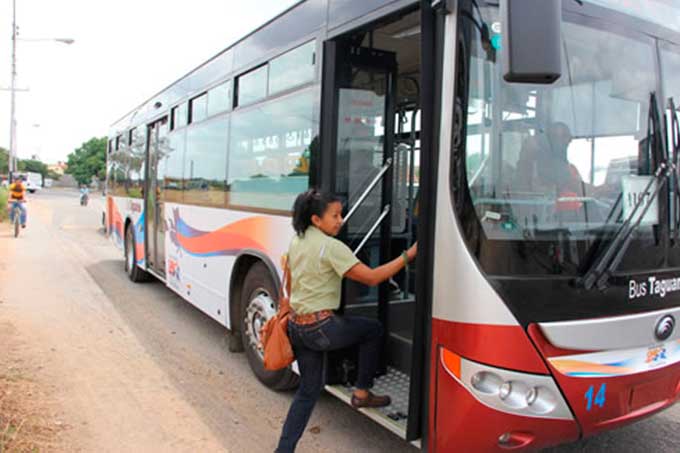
[184,116,229,207]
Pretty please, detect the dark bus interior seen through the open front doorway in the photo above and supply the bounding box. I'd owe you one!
[325,10,421,438]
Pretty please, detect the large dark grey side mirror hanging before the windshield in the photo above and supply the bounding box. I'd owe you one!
[501,0,562,84]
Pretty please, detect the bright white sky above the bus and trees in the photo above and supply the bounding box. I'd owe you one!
[0,0,297,163]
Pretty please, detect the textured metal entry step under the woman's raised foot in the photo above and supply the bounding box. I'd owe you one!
[326,367,409,439]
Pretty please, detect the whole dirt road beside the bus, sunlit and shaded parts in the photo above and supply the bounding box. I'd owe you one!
[0,190,680,453]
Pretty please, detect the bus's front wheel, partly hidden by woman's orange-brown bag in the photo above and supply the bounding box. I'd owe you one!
[240,261,299,390]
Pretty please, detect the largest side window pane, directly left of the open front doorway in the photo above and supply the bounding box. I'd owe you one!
[229,90,318,211]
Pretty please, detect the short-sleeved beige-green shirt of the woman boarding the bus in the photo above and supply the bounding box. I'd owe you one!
[288,226,359,314]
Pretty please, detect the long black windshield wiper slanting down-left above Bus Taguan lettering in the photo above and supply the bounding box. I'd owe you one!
[579,93,675,290]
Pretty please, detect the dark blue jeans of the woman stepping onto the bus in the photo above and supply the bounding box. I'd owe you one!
[276,315,383,453]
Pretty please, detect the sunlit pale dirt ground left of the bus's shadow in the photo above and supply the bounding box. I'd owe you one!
[0,194,228,452]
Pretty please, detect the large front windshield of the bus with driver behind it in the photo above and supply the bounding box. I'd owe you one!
[454,3,677,273]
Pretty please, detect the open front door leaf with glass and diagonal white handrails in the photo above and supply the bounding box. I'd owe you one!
[334,40,397,364]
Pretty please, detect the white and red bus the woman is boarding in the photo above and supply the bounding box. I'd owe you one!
[106,0,680,452]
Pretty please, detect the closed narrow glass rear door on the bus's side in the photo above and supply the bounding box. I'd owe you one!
[145,117,168,276]
